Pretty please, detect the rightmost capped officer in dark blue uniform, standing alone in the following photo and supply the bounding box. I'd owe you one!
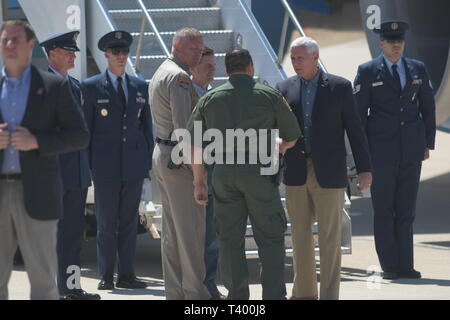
[354,21,436,279]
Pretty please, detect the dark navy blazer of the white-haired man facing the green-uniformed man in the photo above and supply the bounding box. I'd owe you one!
[276,72,371,188]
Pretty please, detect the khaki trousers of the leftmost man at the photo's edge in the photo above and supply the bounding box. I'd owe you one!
[0,180,59,300]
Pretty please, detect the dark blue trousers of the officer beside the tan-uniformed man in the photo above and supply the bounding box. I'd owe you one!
[94,180,143,280]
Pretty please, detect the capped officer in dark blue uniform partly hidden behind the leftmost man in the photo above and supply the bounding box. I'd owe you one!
[40,31,100,300]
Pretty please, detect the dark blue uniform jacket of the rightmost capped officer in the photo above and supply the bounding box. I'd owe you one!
[354,55,436,163]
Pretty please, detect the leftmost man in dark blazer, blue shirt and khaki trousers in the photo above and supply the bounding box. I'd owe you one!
[0,21,89,299]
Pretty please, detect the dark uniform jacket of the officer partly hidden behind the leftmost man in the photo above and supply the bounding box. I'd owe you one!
[48,68,91,190]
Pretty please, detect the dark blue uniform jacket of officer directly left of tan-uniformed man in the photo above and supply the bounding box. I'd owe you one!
[81,72,154,181]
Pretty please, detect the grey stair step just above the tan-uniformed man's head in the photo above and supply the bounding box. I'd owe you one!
[108,8,222,32]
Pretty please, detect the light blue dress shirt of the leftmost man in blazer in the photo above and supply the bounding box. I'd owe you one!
[0,66,31,174]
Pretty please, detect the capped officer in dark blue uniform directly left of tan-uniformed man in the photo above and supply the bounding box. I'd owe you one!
[82,31,153,290]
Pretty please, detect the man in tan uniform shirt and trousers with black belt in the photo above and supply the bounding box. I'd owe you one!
[149,28,210,300]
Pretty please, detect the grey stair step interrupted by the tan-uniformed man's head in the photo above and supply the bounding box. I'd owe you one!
[131,30,234,54]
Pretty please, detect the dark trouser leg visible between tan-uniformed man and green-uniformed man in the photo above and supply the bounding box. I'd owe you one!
[204,166,220,296]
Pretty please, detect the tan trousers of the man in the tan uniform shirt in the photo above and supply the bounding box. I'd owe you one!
[153,144,211,300]
